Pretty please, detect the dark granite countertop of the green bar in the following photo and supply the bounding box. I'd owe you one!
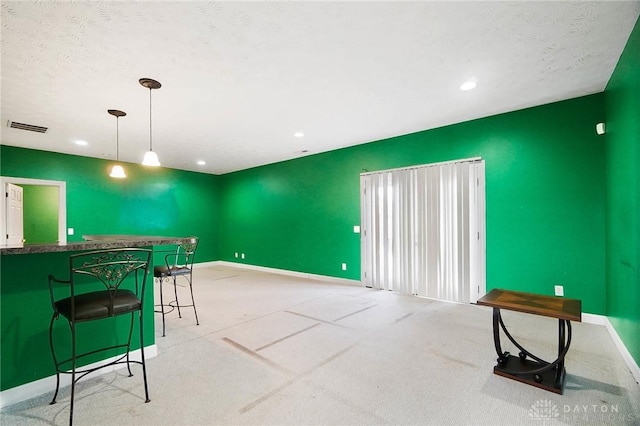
[0,235,195,255]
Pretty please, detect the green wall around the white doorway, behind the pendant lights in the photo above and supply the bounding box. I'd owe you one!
[0,145,220,262]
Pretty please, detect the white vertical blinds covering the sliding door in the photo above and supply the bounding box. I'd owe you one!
[360,159,485,302]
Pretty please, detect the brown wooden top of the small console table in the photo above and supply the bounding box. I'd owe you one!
[477,288,582,322]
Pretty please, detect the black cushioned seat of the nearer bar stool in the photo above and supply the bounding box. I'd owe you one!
[54,290,140,322]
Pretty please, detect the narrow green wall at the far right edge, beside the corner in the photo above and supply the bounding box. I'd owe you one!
[605,20,640,364]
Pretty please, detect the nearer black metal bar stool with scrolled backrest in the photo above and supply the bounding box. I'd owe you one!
[49,248,151,425]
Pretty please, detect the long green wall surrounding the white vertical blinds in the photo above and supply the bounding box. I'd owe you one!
[220,94,606,314]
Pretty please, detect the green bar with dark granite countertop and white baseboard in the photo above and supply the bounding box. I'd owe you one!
[0,235,194,405]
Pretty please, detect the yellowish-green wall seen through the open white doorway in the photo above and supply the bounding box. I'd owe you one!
[20,185,60,244]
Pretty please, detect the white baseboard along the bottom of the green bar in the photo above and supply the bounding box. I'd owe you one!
[0,345,158,408]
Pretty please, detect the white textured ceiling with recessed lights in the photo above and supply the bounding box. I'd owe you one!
[0,0,640,174]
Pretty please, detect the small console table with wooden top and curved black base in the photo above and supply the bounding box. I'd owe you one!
[477,289,582,394]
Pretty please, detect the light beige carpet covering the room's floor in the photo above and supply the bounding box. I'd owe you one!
[0,266,640,425]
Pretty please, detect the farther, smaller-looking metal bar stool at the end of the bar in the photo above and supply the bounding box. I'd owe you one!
[153,238,200,337]
